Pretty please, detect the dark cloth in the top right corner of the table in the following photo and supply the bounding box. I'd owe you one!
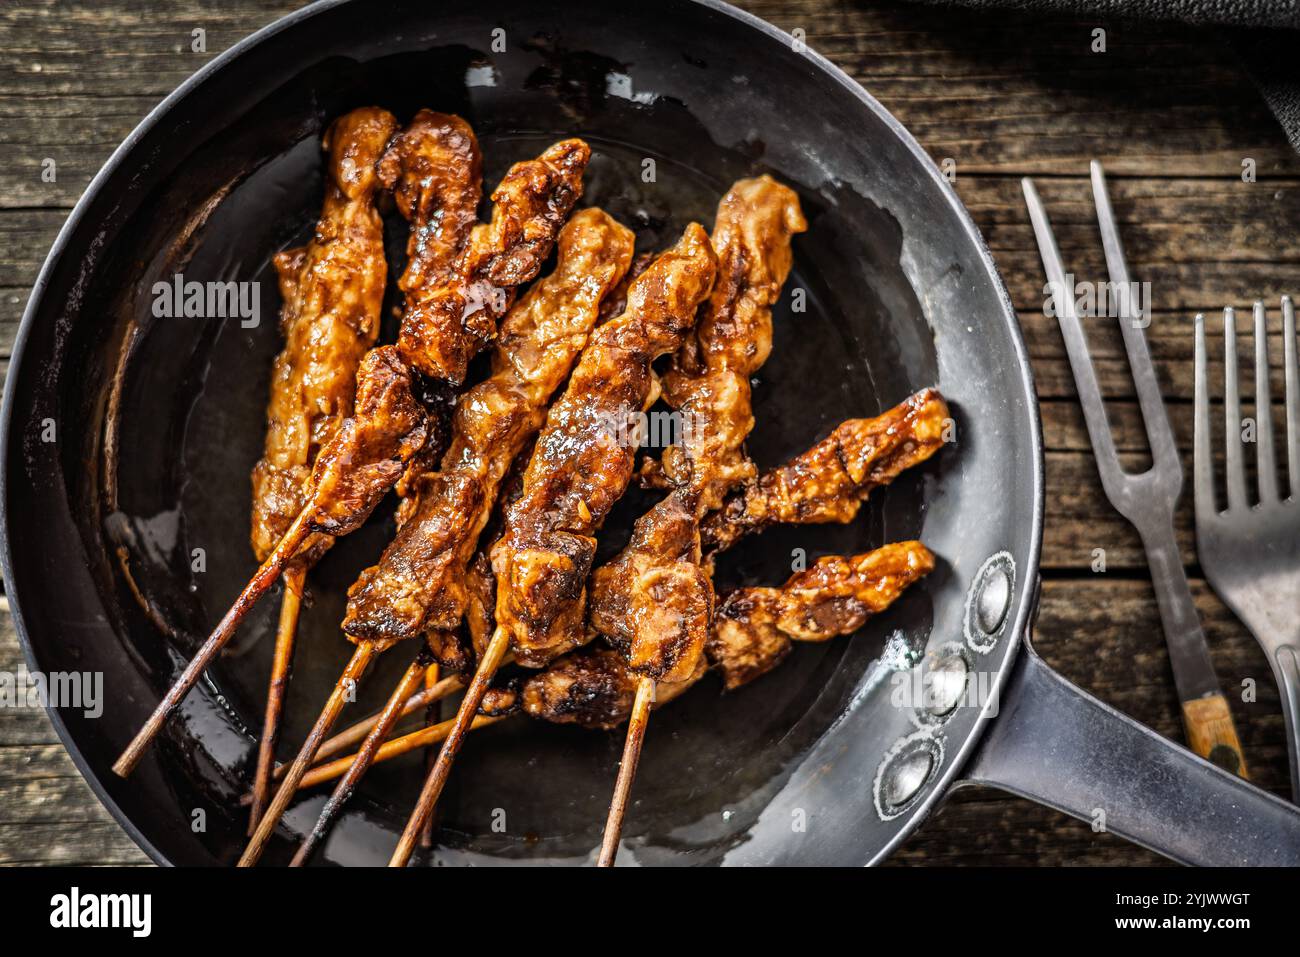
[909,0,1300,152]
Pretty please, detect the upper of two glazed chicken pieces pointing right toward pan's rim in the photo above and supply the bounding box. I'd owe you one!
[702,389,949,554]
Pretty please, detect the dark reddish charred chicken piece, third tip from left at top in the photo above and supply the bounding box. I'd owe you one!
[398,139,592,385]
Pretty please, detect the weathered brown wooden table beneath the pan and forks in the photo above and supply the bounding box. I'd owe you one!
[0,0,1300,865]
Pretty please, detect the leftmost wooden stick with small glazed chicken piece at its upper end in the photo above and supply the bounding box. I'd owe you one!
[113,346,426,778]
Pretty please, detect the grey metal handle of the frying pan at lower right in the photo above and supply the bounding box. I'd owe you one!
[962,642,1300,867]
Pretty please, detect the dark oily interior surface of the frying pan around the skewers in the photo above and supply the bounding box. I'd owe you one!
[9,4,1024,863]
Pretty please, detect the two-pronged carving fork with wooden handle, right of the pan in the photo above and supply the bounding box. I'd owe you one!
[1022,163,1247,778]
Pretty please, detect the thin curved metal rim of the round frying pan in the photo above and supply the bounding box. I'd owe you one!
[0,0,1045,866]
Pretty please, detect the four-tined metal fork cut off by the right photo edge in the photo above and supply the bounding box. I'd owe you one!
[1193,296,1300,802]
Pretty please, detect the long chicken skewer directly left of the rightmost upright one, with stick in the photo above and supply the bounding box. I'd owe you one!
[390,224,718,866]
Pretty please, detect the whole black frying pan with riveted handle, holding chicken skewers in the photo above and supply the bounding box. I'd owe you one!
[0,0,1300,865]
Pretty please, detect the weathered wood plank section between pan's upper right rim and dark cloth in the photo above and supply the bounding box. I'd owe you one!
[744,0,1300,177]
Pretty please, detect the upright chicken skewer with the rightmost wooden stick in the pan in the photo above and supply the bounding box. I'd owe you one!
[592,176,807,866]
